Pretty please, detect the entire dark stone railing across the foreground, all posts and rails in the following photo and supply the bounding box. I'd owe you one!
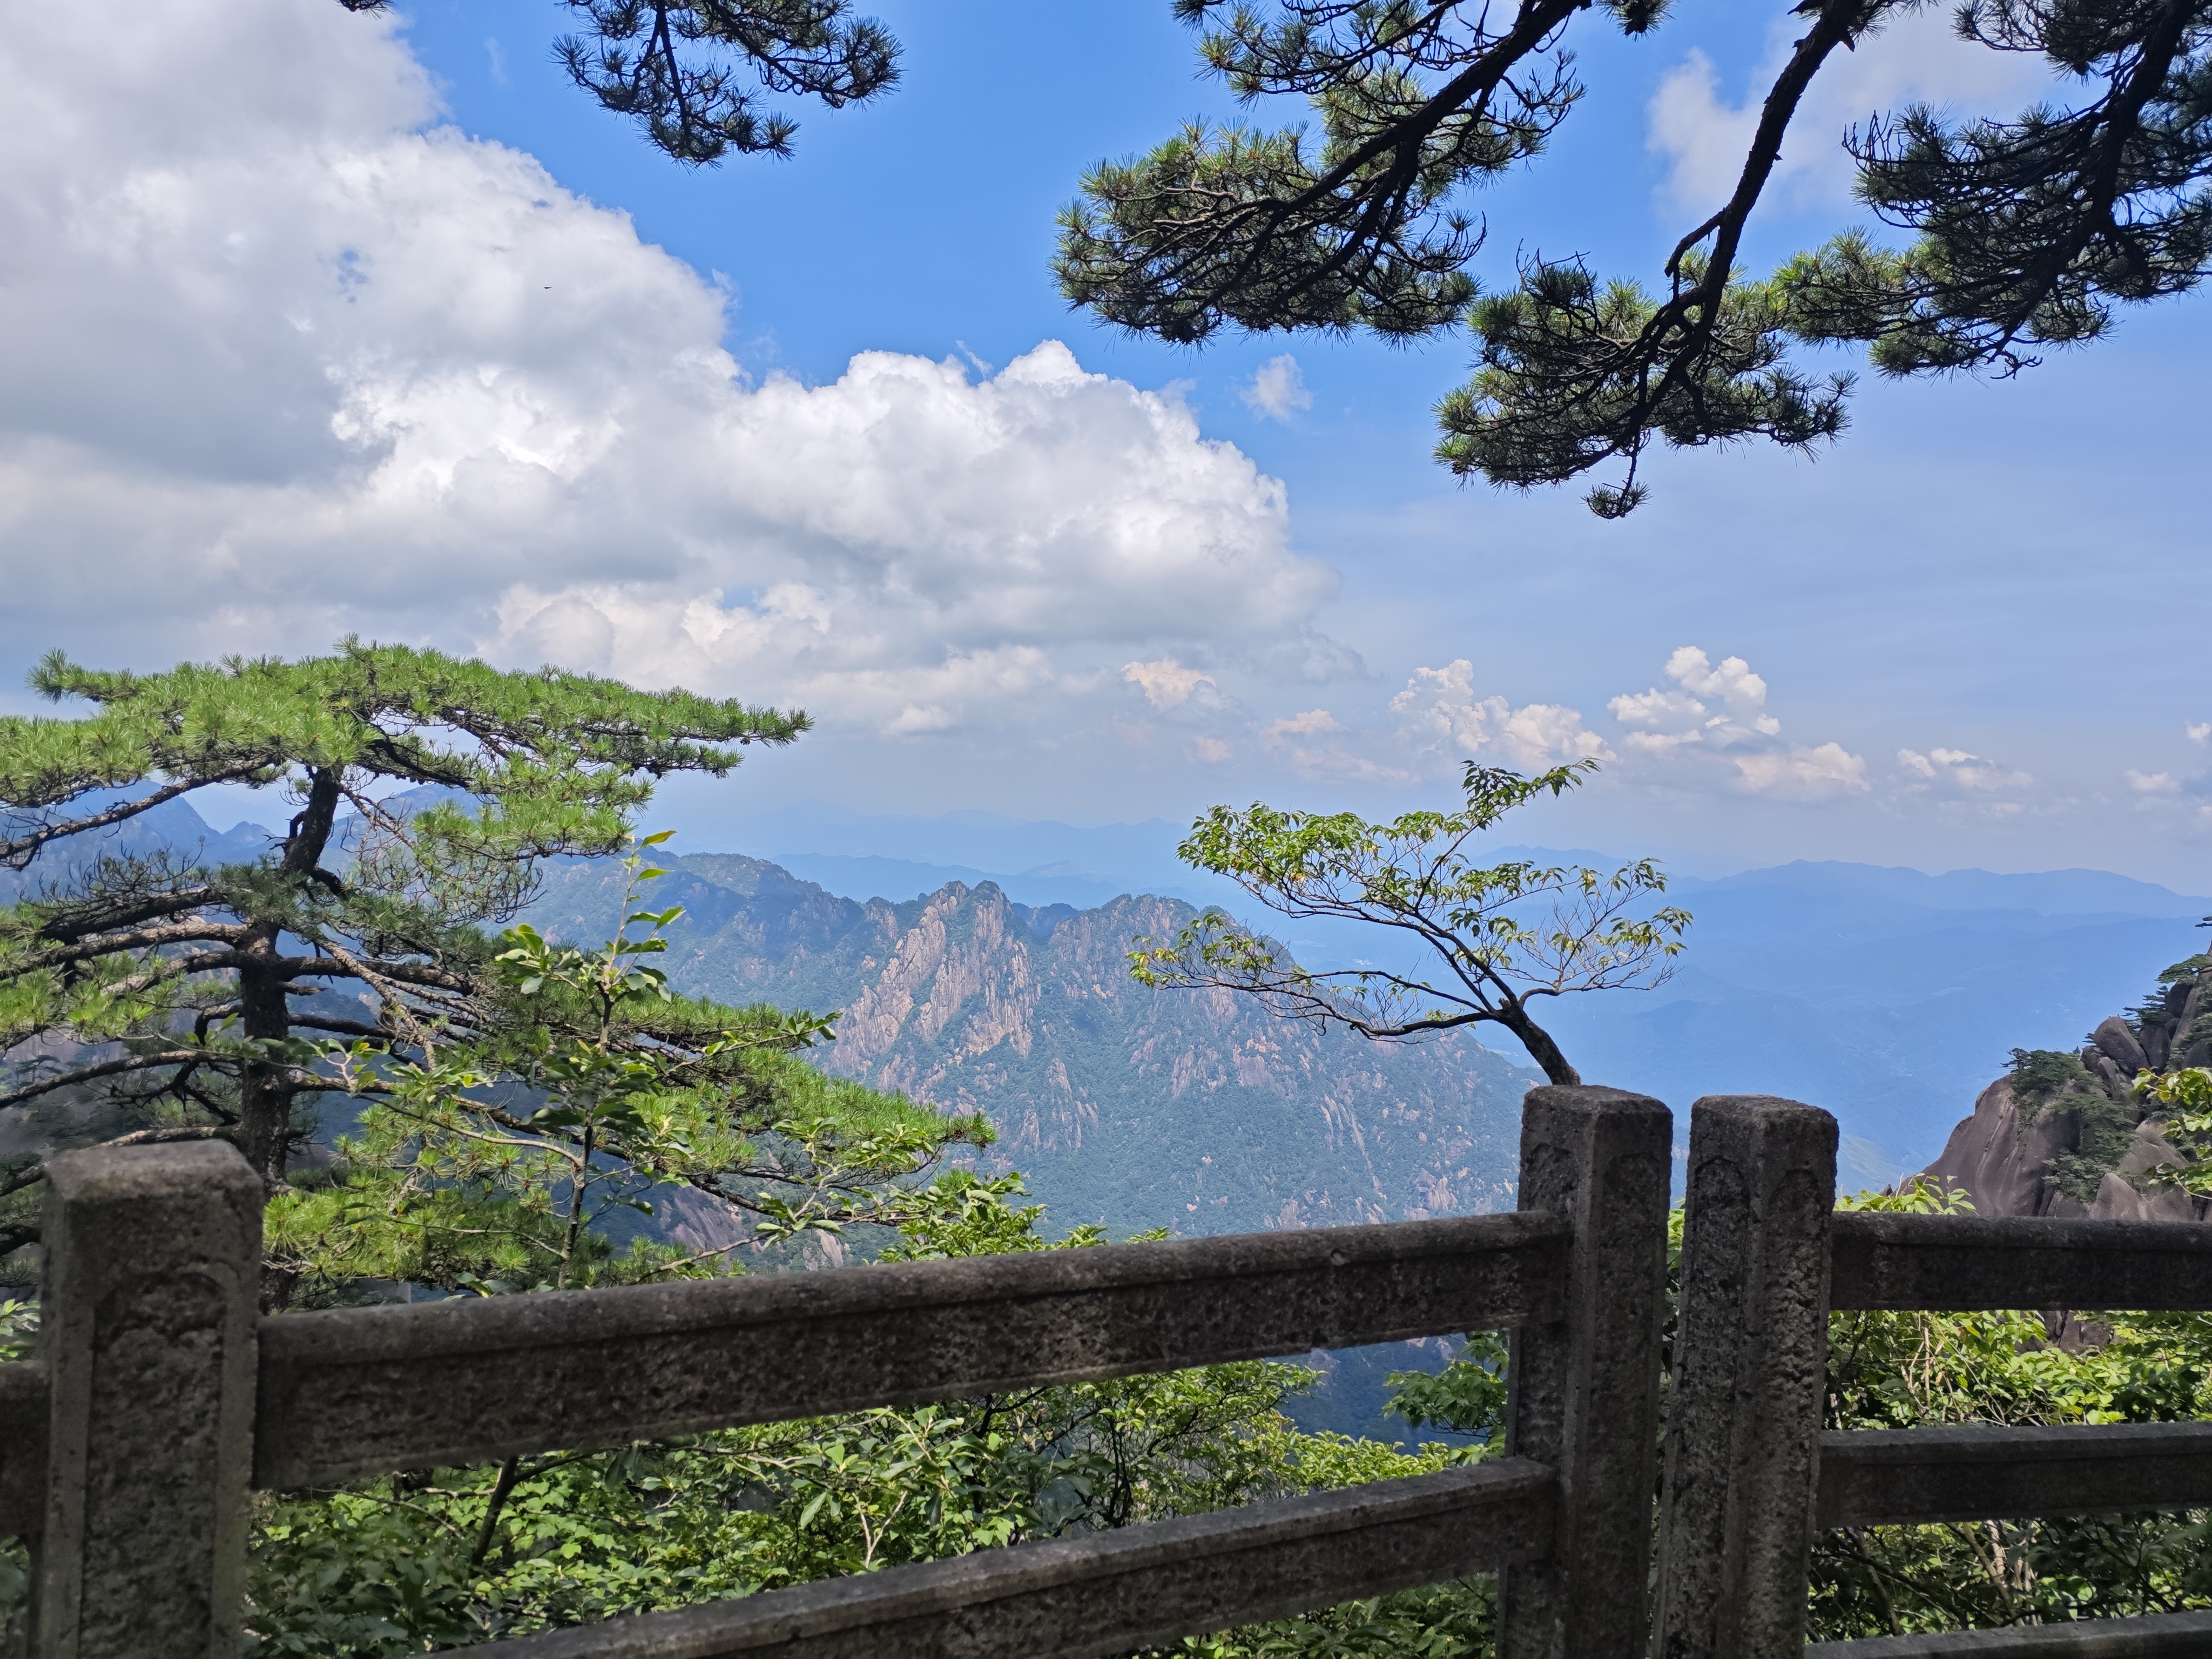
[0,1088,2212,1659]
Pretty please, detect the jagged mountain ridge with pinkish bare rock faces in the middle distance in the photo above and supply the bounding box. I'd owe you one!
[531,854,1542,1232]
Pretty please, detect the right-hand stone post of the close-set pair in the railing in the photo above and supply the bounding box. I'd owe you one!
[1653,1095,1836,1659]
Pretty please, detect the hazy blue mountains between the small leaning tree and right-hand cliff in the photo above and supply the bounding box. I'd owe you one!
[1553,865,2212,1183]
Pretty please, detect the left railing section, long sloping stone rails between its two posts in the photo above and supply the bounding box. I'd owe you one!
[0,1088,1673,1659]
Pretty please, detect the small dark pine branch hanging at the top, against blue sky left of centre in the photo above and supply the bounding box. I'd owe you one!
[339,0,898,166]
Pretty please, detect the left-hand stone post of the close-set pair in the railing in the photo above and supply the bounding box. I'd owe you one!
[1498,1088,1675,1659]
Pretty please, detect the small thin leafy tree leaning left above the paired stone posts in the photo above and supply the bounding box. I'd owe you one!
[1130,761,1690,1084]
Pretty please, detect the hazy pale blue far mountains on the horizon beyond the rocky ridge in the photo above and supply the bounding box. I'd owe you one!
[701,810,2212,1185]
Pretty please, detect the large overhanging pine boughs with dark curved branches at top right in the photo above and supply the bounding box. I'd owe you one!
[1055,0,2212,517]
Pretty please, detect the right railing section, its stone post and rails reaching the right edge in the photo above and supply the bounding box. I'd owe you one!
[1653,1097,2212,1659]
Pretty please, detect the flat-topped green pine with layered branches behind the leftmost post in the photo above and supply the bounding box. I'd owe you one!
[0,639,823,1181]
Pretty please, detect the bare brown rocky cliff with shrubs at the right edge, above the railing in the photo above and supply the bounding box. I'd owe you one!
[1925,955,2212,1221]
